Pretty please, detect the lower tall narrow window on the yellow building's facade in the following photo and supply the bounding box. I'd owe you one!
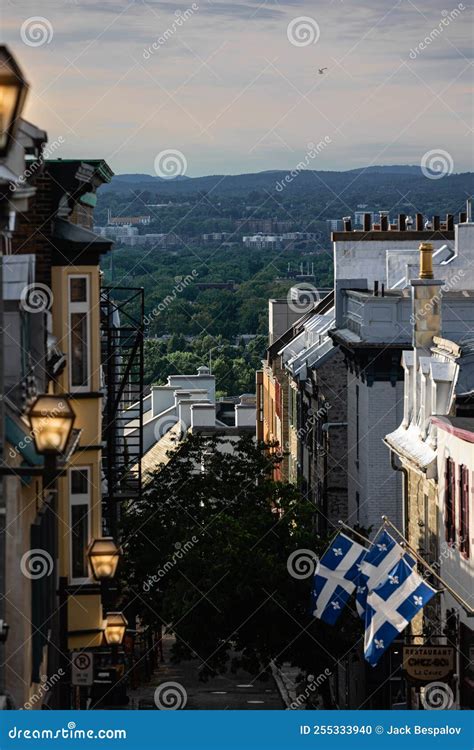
[69,468,91,580]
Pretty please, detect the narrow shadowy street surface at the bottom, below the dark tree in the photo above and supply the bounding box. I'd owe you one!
[129,637,284,710]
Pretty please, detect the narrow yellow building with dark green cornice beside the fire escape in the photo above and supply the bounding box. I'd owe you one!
[47,160,112,650]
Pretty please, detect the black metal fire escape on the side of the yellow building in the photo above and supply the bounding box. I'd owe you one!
[101,287,144,539]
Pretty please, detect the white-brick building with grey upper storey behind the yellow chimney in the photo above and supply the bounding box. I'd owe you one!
[329,212,474,530]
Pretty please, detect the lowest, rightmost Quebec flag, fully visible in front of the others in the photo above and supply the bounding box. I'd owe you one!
[364,559,437,667]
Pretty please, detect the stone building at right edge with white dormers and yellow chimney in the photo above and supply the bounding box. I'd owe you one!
[385,244,474,707]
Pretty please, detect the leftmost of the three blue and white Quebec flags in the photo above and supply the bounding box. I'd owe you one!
[312,533,367,625]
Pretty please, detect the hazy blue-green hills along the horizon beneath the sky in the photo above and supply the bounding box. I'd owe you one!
[96,165,474,229]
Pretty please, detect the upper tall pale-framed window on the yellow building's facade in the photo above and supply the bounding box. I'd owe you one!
[69,276,90,390]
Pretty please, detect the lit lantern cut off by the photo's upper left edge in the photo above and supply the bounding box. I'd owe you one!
[0,45,28,156]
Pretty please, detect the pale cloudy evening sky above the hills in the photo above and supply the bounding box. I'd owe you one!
[2,0,474,177]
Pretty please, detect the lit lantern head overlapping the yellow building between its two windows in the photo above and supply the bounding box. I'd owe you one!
[28,394,76,456]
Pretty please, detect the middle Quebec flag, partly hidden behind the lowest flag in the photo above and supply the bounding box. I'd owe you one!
[356,529,415,619]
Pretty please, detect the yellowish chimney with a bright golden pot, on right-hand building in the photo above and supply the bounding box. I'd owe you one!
[411,242,443,355]
